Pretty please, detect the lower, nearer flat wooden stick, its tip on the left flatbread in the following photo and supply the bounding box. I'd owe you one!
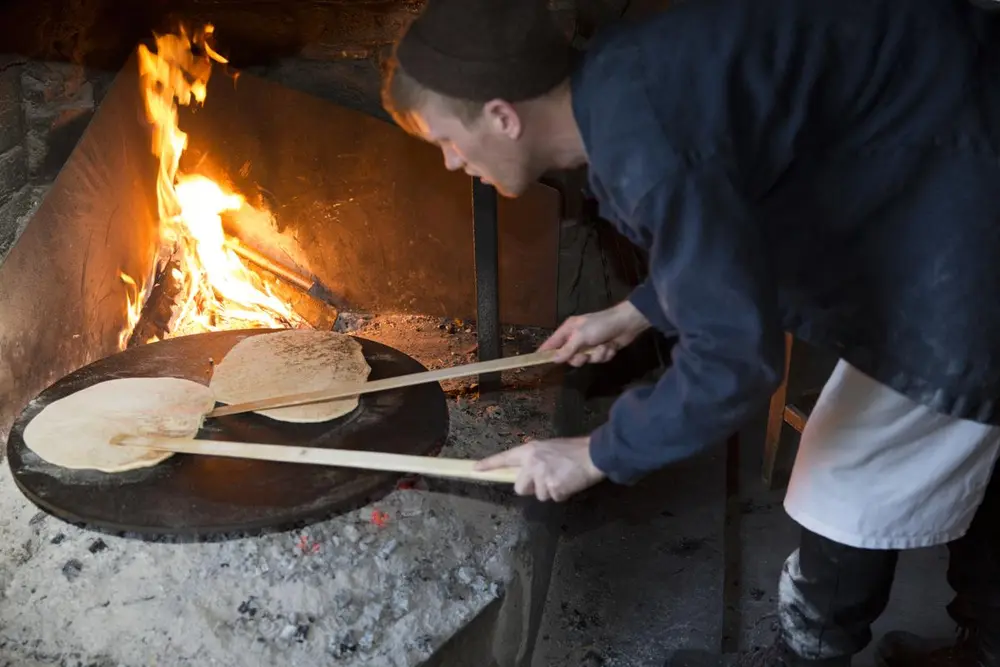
[112,435,518,484]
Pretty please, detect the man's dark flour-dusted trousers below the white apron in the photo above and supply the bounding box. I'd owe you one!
[779,466,1000,659]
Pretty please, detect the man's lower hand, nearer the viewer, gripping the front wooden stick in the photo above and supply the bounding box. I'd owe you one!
[476,436,605,502]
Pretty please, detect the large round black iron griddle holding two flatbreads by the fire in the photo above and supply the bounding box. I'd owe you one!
[7,329,448,535]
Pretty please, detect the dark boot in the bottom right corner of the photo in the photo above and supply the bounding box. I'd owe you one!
[875,630,1000,667]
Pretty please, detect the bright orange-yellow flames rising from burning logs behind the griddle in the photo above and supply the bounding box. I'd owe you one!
[120,25,302,349]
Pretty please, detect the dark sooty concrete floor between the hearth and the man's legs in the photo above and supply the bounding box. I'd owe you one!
[534,352,953,667]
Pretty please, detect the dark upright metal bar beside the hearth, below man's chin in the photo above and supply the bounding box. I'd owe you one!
[472,178,502,393]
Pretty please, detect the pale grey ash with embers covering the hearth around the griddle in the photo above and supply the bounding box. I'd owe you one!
[0,318,550,667]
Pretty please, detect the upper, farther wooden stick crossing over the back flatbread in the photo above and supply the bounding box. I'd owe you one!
[205,350,556,418]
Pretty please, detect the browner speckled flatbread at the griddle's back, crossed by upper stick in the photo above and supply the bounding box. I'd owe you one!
[209,330,371,423]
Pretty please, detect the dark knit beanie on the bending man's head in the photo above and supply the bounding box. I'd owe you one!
[396,0,573,102]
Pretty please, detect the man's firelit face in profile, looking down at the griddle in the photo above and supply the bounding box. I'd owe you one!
[409,96,538,197]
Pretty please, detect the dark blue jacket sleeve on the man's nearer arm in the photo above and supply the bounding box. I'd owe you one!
[590,161,784,484]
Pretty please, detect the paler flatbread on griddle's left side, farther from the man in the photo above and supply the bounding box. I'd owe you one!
[24,378,215,473]
